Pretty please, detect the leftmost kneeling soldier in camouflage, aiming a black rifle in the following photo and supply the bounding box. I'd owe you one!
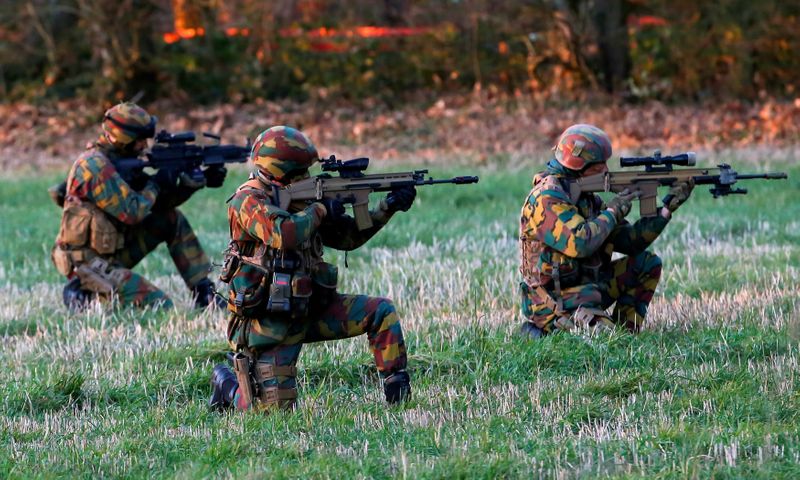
[52,103,226,309]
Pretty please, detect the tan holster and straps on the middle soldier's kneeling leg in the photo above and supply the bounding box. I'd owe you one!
[233,352,297,411]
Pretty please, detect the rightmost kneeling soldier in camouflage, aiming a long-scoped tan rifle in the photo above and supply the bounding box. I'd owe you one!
[519,124,693,338]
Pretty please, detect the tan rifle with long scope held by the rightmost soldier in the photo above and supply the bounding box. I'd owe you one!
[570,150,787,217]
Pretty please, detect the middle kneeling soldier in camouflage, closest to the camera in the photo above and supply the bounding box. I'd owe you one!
[210,126,416,411]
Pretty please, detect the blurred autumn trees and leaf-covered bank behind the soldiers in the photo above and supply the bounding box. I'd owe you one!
[0,0,800,170]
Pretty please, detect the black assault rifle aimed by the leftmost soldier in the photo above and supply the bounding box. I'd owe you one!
[113,130,250,190]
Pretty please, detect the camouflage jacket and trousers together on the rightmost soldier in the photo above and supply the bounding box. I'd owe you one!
[520,160,668,332]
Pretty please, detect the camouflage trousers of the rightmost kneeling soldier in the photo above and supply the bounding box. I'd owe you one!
[520,251,661,332]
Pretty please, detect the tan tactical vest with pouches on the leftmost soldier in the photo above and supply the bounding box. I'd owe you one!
[51,159,124,276]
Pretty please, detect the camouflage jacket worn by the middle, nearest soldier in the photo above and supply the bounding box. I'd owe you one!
[228,176,391,316]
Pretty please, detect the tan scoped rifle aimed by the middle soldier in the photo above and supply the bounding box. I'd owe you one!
[276,155,478,230]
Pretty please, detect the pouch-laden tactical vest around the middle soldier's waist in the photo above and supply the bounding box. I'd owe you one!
[220,177,338,319]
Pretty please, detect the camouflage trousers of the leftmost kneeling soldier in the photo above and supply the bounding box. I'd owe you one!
[113,208,211,307]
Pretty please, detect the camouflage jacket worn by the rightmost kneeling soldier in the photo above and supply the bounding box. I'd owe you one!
[519,162,668,288]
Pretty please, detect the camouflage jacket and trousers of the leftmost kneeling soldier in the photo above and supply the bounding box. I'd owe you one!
[53,104,216,307]
